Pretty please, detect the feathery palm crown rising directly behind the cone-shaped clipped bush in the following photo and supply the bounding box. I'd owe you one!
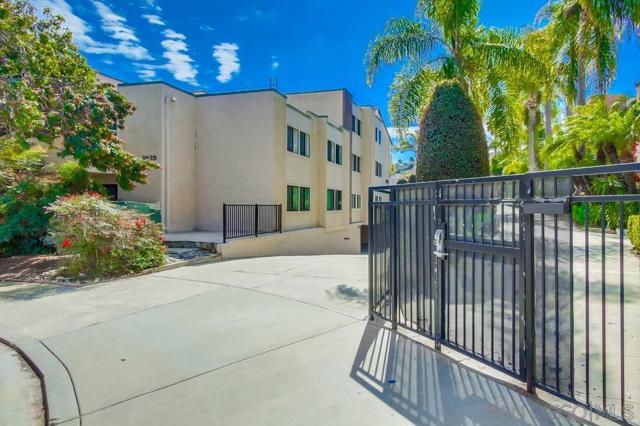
[365,0,542,143]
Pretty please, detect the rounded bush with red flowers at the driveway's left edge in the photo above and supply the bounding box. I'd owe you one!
[47,194,165,278]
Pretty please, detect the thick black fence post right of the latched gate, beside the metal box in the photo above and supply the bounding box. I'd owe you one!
[520,176,544,393]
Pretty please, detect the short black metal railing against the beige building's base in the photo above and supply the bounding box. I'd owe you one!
[222,204,282,243]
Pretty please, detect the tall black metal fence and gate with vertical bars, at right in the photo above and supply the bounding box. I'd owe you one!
[369,163,640,424]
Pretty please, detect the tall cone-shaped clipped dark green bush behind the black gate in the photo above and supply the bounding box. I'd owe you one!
[417,81,489,181]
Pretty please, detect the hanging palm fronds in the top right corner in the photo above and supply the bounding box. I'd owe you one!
[539,0,640,105]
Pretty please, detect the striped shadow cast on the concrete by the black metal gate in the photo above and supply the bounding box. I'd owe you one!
[351,321,573,426]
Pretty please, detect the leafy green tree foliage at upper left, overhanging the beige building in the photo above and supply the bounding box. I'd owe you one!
[0,0,157,189]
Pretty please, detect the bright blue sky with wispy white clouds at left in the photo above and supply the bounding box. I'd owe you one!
[32,0,640,130]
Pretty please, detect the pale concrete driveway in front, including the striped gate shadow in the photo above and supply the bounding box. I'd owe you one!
[0,256,578,426]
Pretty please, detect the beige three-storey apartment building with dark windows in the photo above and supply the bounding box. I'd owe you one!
[96,75,391,253]
